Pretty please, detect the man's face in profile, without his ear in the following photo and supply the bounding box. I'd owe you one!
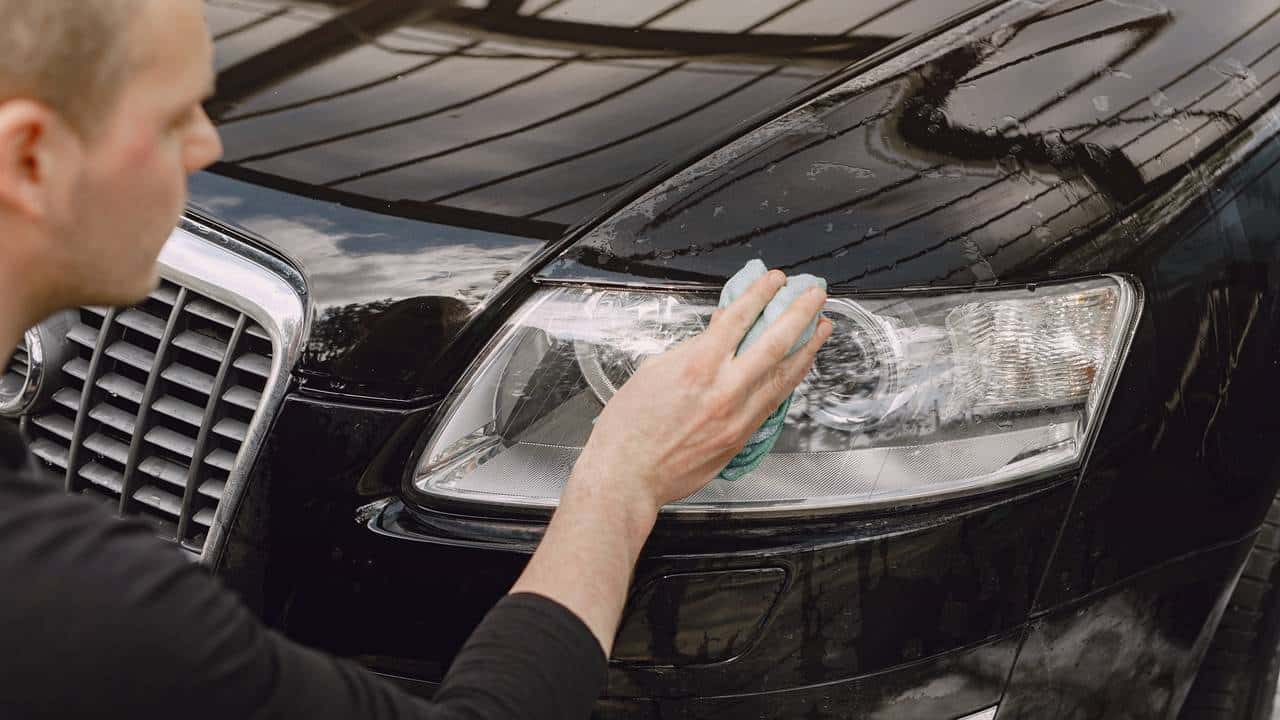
[58,0,221,305]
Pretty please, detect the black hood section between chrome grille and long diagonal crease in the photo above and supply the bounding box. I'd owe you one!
[192,0,988,398]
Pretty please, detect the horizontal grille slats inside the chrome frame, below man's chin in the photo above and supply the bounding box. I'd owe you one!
[28,281,274,553]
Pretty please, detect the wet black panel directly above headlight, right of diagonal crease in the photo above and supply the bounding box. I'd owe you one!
[544,0,1280,292]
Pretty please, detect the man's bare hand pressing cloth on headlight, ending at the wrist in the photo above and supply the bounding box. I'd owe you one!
[571,270,832,512]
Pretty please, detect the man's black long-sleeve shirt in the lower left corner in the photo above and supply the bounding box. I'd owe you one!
[0,423,605,720]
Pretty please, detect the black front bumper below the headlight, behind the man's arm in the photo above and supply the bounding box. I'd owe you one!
[219,379,1252,720]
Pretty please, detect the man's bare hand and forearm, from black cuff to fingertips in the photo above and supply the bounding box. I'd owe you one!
[512,270,832,655]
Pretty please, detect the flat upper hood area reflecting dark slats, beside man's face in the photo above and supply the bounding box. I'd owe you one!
[207,0,972,228]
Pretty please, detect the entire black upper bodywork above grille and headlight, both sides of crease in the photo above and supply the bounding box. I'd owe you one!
[192,0,1280,398]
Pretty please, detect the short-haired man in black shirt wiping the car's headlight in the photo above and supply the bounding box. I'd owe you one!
[0,0,831,720]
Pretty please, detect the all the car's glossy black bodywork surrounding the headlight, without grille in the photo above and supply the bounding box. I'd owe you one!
[7,0,1280,720]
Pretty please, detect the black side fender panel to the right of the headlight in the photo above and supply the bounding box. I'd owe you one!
[1039,127,1280,607]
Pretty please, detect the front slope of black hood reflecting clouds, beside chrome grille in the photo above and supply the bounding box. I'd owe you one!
[191,173,543,400]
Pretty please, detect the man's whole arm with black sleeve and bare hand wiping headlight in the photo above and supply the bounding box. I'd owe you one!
[0,267,831,720]
